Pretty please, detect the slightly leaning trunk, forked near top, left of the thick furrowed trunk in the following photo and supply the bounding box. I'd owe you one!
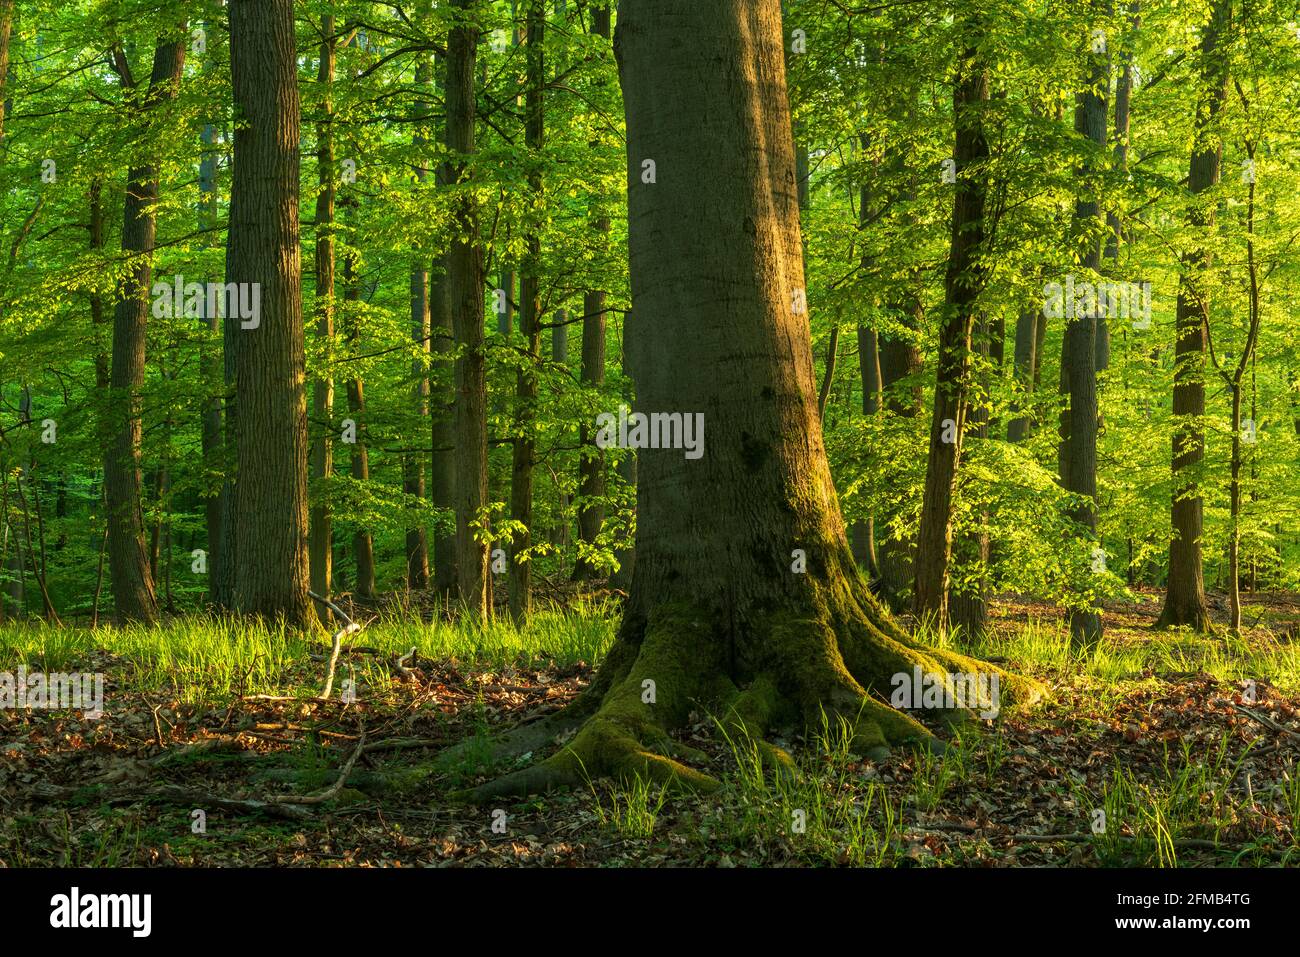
[104,35,185,624]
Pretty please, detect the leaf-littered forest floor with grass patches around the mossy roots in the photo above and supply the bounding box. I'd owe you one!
[0,594,1300,867]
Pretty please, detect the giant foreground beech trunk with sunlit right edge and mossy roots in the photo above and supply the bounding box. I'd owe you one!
[462,0,1032,800]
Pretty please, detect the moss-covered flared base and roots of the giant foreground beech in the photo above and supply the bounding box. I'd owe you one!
[459,581,1045,801]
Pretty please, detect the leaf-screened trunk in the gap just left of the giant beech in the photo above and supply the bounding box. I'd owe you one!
[573,4,610,580]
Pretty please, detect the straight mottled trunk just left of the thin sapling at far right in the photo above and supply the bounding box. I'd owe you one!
[1157,0,1232,631]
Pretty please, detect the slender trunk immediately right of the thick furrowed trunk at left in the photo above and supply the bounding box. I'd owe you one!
[307,14,338,605]
